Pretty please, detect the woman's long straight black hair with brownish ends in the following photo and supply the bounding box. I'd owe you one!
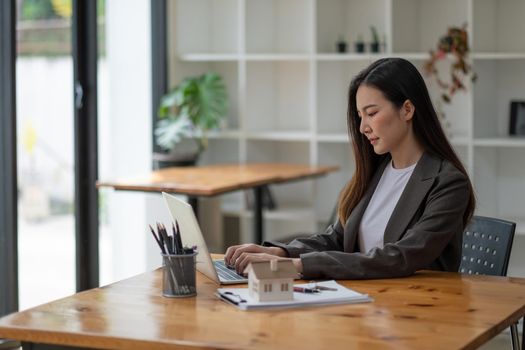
[338,58,476,226]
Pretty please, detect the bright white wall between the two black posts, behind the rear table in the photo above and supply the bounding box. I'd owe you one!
[103,0,154,280]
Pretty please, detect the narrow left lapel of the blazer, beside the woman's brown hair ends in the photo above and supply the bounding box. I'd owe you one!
[344,157,390,252]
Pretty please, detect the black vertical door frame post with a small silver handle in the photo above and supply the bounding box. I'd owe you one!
[72,0,99,292]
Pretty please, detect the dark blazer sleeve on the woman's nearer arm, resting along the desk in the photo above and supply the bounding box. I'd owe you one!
[278,163,469,279]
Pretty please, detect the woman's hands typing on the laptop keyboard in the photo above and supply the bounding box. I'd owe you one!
[224,243,286,274]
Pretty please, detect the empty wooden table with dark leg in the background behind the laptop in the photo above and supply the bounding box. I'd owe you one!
[97,163,339,243]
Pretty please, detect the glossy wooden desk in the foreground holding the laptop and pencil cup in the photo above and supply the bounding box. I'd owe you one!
[0,270,525,350]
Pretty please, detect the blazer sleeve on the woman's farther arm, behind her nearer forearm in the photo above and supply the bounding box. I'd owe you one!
[263,219,344,258]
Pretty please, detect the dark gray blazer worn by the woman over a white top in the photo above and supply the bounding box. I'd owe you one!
[265,153,469,279]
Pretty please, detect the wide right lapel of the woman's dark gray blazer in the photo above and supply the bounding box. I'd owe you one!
[384,152,441,244]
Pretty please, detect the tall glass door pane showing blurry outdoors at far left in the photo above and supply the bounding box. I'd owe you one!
[16,0,75,310]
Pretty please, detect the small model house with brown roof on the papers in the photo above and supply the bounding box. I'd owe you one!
[245,260,297,301]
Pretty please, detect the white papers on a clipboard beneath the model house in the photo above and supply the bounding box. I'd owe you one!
[216,280,372,310]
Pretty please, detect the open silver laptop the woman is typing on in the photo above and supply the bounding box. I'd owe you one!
[162,192,248,284]
